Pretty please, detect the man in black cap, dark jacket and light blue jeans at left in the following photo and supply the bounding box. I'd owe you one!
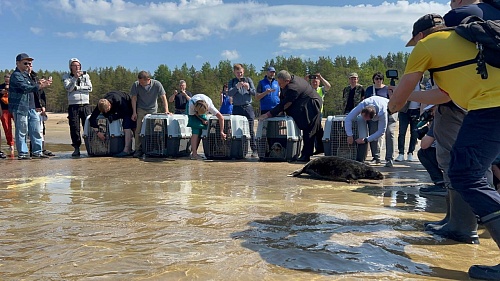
[9,53,52,160]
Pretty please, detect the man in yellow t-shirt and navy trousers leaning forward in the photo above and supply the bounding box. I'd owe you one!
[389,13,500,276]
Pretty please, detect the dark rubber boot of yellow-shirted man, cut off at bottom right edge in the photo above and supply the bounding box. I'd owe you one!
[469,217,500,280]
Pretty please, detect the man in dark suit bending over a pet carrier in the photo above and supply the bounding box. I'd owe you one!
[259,70,323,162]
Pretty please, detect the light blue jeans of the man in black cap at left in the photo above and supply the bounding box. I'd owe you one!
[13,109,42,155]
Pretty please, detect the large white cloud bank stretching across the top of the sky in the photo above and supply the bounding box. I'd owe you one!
[49,0,449,51]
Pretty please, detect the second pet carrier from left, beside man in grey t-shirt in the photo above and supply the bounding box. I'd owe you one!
[140,113,191,157]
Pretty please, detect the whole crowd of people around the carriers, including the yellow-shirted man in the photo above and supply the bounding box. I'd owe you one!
[0,0,500,280]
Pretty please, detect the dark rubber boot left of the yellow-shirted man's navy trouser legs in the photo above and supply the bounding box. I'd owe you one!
[425,188,479,244]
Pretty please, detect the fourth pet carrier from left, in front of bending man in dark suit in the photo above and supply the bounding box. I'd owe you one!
[256,116,302,161]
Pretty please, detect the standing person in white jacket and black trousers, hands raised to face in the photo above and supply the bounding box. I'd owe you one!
[63,58,92,157]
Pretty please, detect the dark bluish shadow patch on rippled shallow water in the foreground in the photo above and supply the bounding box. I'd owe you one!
[232,213,432,275]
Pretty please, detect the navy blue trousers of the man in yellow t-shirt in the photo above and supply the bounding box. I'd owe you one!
[448,107,500,219]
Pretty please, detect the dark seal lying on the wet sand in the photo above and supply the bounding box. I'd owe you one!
[288,156,384,183]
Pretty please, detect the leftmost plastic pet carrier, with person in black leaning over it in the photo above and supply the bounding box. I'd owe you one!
[83,114,125,156]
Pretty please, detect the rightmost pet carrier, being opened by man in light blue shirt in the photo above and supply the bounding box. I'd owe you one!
[323,115,366,160]
